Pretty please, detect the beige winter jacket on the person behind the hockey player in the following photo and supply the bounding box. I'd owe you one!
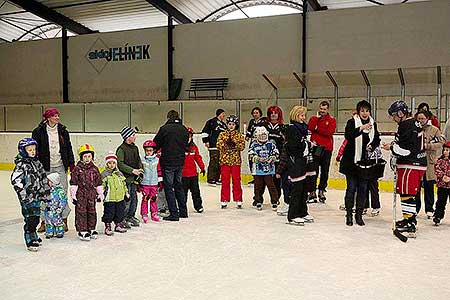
[422,124,445,181]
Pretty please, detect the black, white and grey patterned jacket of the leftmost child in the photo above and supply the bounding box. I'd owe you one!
[11,155,50,205]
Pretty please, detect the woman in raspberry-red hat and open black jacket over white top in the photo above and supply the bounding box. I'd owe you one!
[31,108,75,232]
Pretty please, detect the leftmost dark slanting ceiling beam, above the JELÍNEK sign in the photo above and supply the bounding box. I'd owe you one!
[8,0,97,34]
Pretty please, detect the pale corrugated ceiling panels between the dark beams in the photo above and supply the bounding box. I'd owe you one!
[0,0,427,41]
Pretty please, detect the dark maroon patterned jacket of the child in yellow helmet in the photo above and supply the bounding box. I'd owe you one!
[70,161,102,203]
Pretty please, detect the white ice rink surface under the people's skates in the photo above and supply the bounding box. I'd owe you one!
[0,171,450,300]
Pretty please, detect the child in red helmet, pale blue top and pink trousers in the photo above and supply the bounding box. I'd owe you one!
[139,140,162,223]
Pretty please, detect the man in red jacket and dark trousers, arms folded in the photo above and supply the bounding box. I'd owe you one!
[308,101,336,203]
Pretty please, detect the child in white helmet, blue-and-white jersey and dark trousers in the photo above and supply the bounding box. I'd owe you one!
[248,127,279,210]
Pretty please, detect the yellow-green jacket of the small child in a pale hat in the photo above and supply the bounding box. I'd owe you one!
[101,168,128,202]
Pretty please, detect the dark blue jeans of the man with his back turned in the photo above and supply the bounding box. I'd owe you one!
[163,166,187,218]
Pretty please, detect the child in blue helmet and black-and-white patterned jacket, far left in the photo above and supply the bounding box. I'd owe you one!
[11,138,50,252]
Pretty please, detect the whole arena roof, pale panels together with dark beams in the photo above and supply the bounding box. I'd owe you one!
[0,0,427,43]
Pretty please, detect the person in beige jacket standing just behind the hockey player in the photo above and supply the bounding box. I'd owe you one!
[415,110,445,219]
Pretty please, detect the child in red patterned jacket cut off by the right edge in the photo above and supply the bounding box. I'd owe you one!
[433,141,450,226]
